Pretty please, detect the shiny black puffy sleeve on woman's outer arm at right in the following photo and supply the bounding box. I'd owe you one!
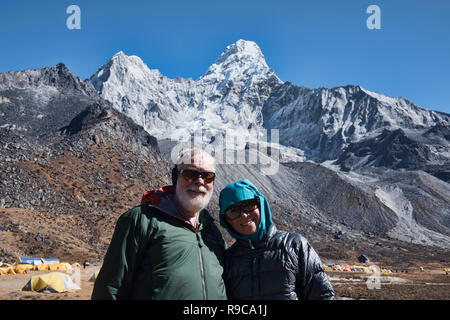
[297,237,334,300]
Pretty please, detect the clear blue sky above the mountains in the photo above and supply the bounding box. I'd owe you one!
[0,0,450,113]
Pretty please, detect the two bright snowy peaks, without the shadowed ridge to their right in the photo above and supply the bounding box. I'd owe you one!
[90,40,282,149]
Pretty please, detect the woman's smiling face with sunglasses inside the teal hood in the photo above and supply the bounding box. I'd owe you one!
[225,200,261,236]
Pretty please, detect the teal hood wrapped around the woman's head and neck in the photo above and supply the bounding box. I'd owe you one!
[219,179,272,249]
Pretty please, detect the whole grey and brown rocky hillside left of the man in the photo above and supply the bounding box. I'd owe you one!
[0,65,169,260]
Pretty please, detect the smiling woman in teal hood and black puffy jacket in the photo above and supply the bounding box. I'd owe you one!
[219,179,334,300]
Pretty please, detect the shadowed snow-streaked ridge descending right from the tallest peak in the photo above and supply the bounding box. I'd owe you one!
[263,82,450,162]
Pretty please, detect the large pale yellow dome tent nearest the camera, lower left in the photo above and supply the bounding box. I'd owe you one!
[22,272,81,292]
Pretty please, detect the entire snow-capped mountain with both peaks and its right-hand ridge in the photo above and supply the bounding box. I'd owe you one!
[90,40,450,170]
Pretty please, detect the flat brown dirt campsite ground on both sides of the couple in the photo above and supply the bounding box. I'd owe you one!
[0,266,450,300]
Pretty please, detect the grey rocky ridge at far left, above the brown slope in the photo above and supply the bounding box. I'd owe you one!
[0,64,100,152]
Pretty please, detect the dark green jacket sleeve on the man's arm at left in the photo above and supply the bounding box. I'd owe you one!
[91,209,148,300]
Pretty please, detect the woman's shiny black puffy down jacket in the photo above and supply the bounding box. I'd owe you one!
[224,226,334,300]
